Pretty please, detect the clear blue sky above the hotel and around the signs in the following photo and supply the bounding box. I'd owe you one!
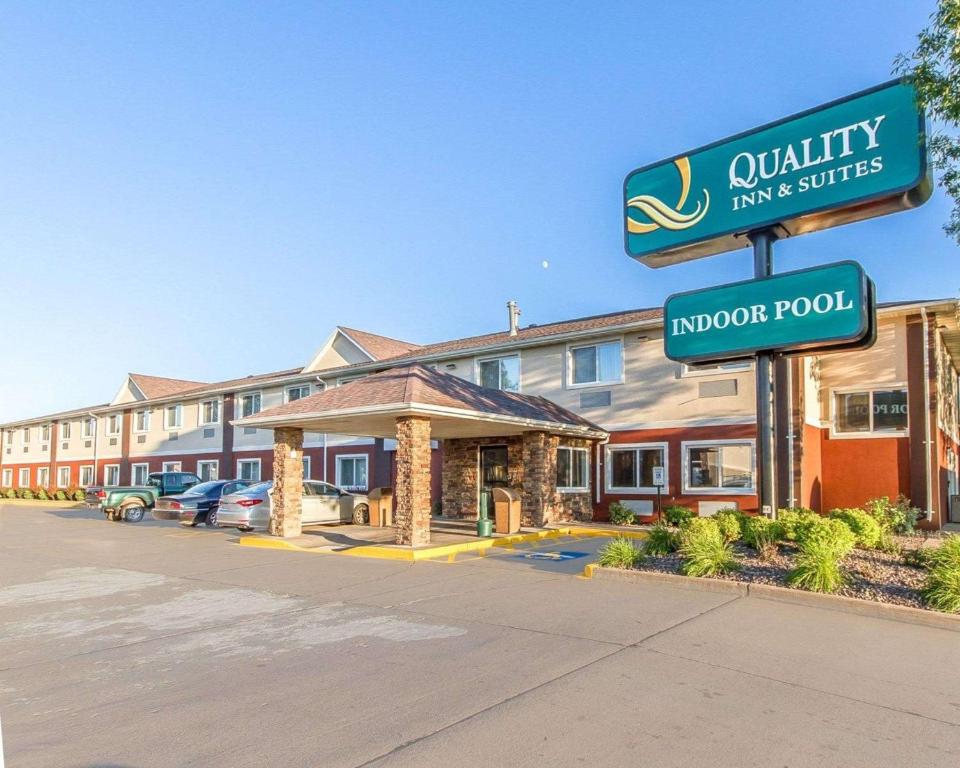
[0,0,948,420]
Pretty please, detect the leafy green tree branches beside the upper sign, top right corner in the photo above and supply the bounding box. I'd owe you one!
[893,0,960,243]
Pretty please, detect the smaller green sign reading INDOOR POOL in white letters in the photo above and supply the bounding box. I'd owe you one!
[664,261,874,363]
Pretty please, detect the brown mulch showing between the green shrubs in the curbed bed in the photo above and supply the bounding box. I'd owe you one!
[640,536,935,608]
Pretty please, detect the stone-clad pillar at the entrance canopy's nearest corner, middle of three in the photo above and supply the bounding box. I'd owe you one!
[393,416,430,547]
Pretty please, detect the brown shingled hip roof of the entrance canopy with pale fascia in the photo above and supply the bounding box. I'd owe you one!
[233,364,607,439]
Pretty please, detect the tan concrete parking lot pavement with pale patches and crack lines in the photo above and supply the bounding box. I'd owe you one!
[0,505,960,768]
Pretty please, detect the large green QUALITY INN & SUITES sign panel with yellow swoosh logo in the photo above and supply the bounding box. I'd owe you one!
[624,80,932,267]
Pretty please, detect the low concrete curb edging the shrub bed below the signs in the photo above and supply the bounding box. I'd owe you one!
[584,566,960,632]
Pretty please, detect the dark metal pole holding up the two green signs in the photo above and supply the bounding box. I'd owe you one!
[748,229,777,517]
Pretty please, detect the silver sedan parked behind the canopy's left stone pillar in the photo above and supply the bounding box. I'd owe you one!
[217,480,370,531]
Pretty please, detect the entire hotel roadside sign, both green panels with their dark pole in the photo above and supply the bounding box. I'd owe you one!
[623,80,933,514]
